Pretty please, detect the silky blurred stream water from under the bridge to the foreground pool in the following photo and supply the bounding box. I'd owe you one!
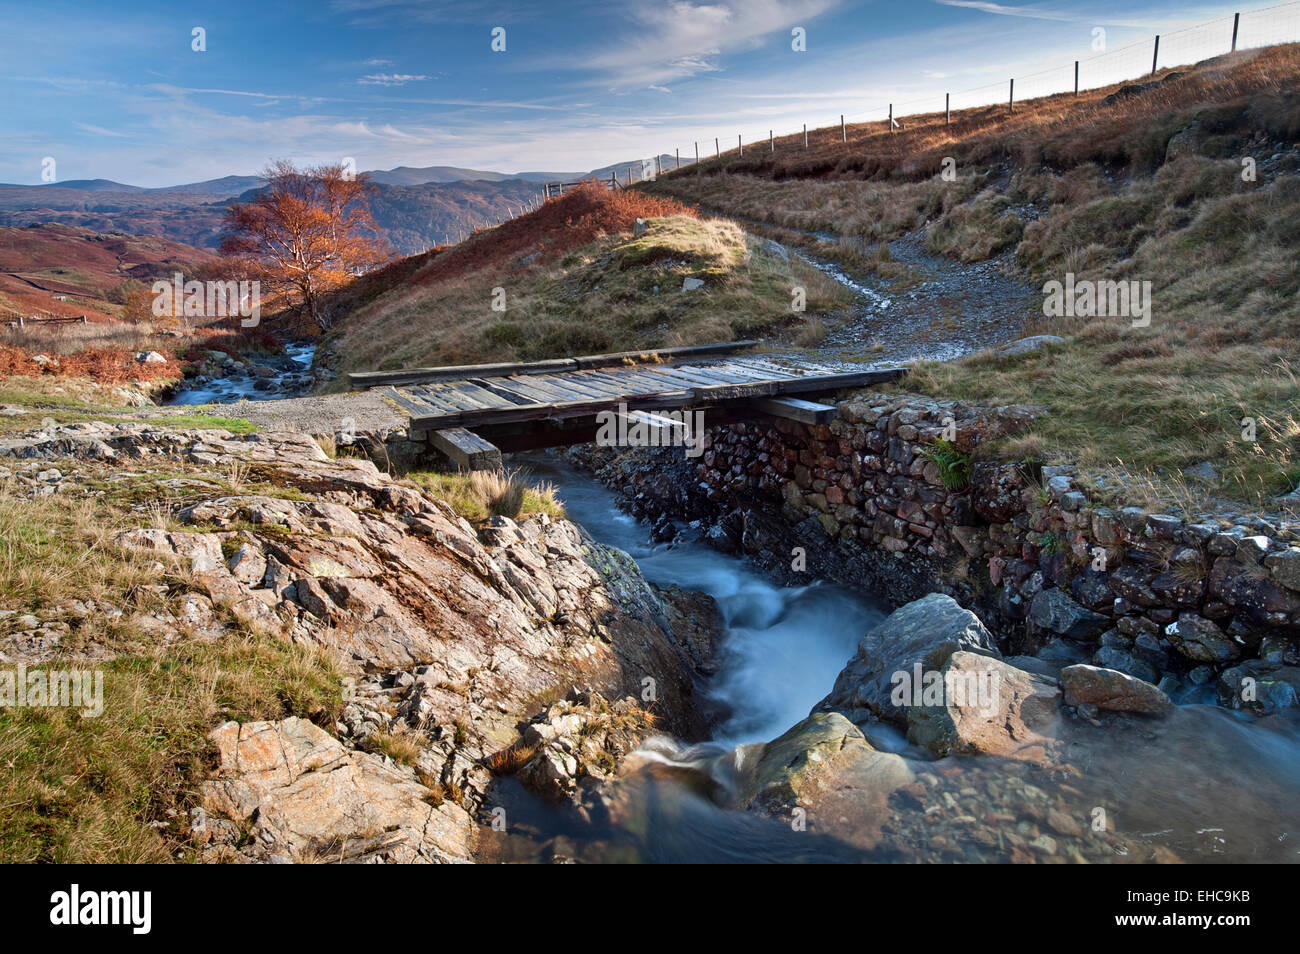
[480,455,1300,862]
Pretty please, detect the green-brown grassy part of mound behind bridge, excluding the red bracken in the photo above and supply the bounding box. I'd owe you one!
[327,216,846,386]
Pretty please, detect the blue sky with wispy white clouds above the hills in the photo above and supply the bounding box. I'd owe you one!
[0,0,1284,186]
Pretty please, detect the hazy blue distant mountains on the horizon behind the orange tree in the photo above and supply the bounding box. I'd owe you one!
[0,156,673,255]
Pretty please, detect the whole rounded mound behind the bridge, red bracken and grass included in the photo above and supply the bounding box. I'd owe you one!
[325,186,845,382]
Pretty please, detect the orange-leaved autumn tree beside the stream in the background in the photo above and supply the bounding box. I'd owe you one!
[221,160,391,330]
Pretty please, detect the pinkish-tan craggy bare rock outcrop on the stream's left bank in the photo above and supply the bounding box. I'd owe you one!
[0,422,711,860]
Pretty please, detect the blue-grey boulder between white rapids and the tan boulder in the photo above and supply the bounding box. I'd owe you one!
[814,593,1001,725]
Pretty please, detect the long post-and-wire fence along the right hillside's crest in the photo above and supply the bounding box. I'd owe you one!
[616,0,1300,185]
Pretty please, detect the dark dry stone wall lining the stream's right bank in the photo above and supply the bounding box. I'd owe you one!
[588,395,1300,711]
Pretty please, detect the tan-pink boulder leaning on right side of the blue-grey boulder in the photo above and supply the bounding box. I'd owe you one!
[907,651,1061,759]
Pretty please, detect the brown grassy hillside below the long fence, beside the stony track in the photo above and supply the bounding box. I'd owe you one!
[644,45,1300,509]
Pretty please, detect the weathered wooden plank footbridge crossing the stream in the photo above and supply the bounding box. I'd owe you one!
[348,341,904,469]
